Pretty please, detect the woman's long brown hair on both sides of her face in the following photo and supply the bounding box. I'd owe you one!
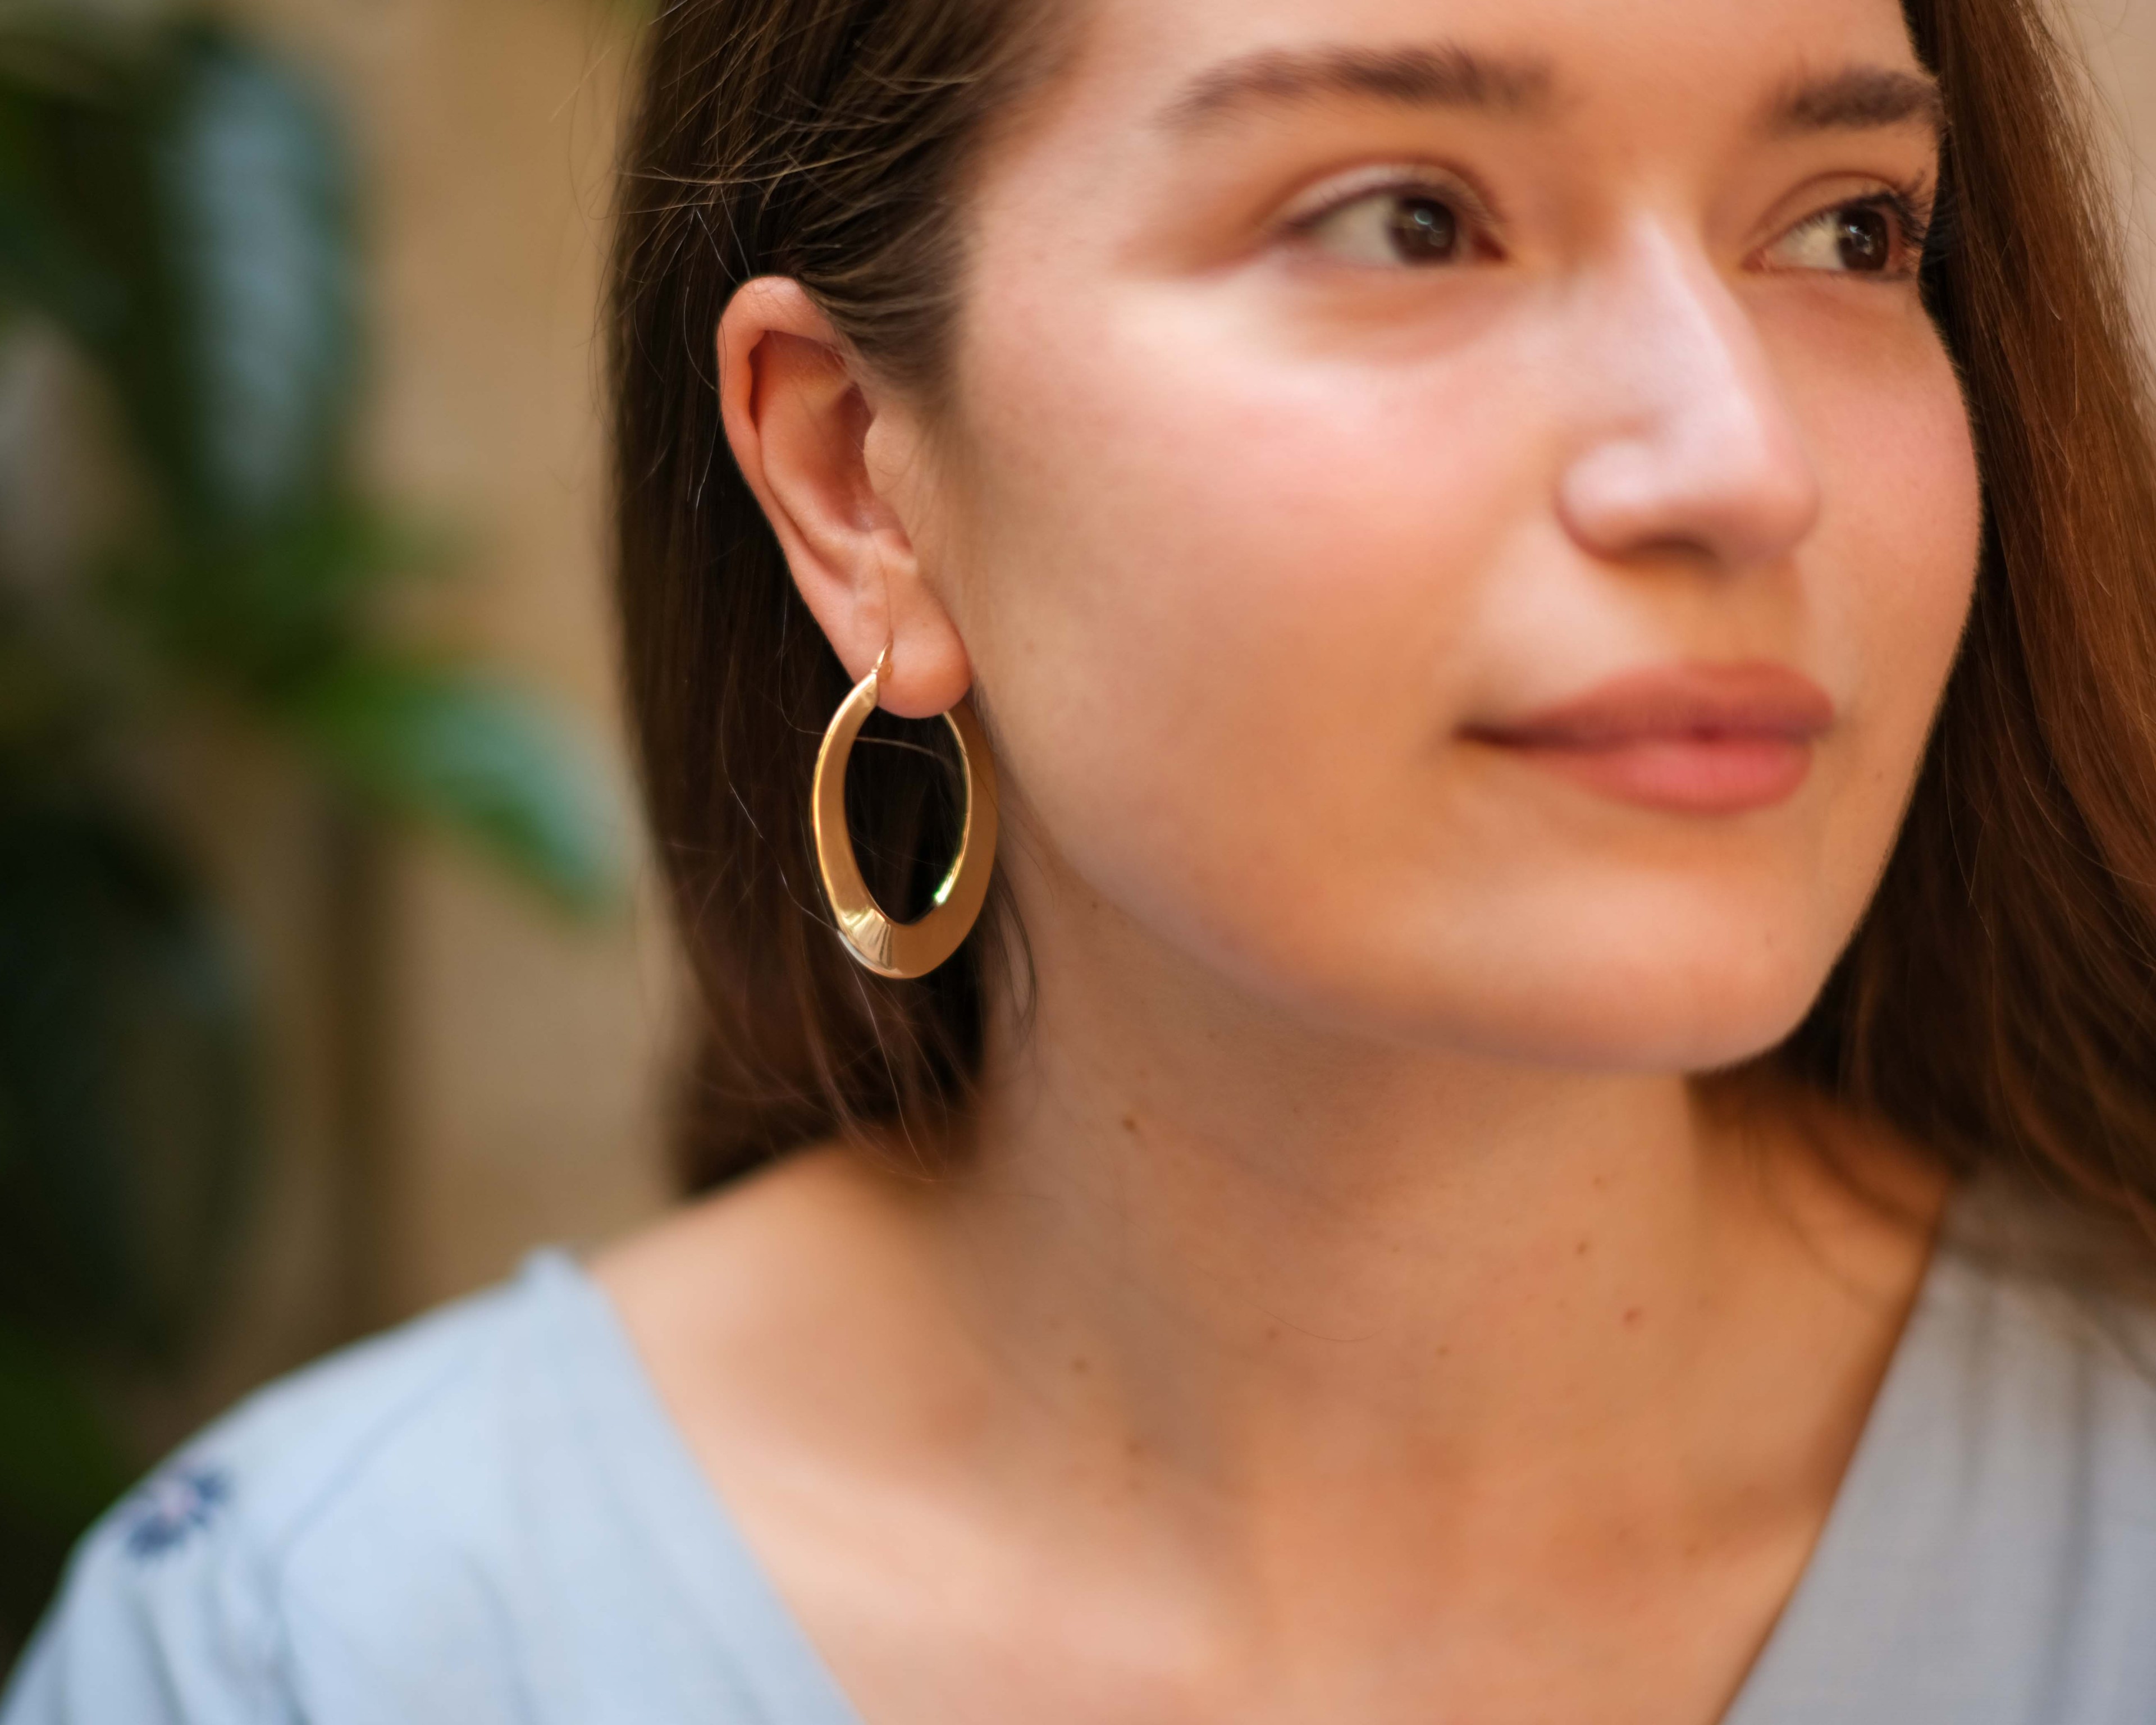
[613,0,2156,1214]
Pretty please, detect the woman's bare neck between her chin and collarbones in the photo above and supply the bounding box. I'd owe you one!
[918,862,1936,1526]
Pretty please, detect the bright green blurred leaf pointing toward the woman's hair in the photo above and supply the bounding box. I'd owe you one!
[287,655,627,914]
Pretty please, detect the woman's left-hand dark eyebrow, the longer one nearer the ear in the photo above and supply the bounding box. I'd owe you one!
[1162,47,1550,131]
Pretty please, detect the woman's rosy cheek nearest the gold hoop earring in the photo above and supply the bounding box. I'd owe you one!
[963,280,1543,964]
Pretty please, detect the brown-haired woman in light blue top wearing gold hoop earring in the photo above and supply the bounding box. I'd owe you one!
[4,0,2156,1725]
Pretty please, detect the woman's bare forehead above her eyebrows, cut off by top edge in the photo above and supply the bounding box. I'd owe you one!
[1026,0,1917,129]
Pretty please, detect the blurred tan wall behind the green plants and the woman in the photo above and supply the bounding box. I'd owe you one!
[0,0,2156,1669]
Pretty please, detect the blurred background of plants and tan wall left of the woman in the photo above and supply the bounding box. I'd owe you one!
[0,0,681,1639]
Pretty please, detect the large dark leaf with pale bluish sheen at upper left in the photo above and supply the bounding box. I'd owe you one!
[0,24,360,532]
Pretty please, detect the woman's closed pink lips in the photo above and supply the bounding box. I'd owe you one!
[1464,660,1835,815]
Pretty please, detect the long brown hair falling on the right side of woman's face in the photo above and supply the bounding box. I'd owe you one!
[1787,0,2156,1231]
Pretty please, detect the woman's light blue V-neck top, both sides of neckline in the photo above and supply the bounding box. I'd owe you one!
[0,1216,2156,1725]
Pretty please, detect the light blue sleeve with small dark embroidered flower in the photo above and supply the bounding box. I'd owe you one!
[0,1462,300,1725]
